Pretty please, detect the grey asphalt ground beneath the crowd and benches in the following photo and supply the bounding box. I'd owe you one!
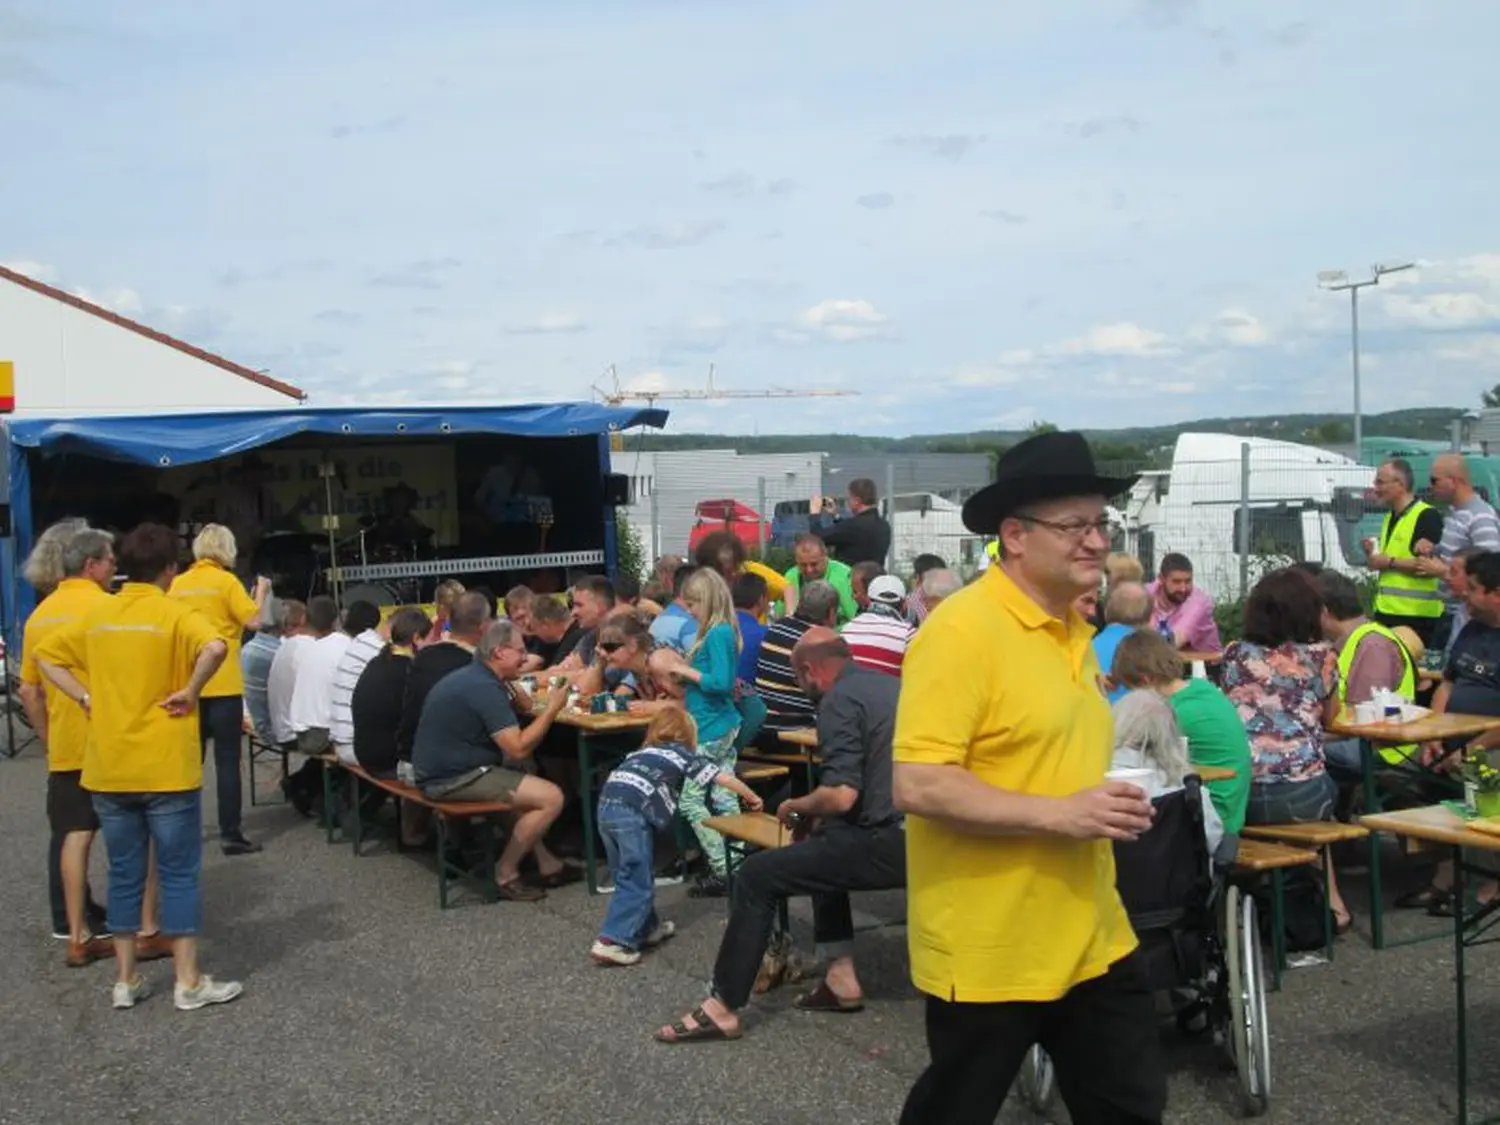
[0,749,1500,1125]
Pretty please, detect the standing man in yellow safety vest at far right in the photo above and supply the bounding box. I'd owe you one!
[1365,458,1443,645]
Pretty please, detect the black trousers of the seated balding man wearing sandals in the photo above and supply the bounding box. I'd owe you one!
[714,825,906,1010]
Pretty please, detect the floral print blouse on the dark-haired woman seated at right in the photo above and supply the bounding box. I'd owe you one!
[1223,641,1338,785]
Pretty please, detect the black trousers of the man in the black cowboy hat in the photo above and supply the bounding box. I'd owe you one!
[902,954,1167,1125]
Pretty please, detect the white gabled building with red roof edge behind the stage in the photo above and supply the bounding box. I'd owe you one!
[0,267,308,417]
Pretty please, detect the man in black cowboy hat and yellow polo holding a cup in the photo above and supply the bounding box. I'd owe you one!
[894,434,1166,1125]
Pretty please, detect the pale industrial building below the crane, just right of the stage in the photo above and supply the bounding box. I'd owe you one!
[611,449,825,558]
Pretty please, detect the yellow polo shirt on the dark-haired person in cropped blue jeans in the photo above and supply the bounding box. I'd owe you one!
[36,582,219,794]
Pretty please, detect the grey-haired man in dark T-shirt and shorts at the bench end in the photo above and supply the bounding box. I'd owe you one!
[411,621,569,903]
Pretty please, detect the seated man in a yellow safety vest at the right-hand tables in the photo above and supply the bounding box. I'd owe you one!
[1317,570,1418,782]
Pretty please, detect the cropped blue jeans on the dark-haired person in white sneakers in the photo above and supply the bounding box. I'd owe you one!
[93,789,203,938]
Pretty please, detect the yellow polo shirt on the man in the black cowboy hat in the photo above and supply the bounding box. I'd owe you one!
[894,566,1136,1004]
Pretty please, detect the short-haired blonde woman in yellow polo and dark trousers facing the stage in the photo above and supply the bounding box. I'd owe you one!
[168,524,272,855]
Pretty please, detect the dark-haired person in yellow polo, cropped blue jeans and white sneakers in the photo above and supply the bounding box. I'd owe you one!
[36,524,240,1011]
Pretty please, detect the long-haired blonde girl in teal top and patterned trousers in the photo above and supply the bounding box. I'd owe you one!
[651,570,740,899]
